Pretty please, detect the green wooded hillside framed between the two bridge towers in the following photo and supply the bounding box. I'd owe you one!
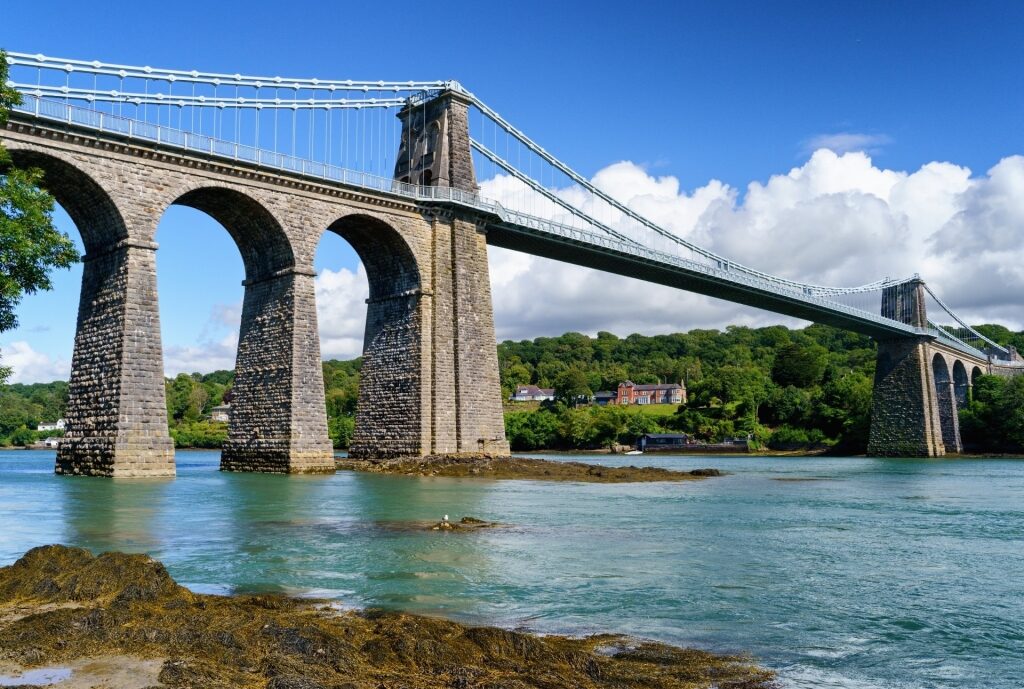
[498,326,876,451]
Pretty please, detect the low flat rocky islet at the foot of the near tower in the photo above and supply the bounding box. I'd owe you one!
[335,455,722,483]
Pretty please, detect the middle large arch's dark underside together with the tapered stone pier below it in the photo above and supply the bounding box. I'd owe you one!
[157,183,334,473]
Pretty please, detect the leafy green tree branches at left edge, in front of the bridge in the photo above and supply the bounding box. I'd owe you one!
[0,50,79,383]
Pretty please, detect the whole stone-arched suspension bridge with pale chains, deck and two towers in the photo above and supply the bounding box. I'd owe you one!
[0,53,1022,475]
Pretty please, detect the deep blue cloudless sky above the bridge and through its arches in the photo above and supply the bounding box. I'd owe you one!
[0,0,1024,380]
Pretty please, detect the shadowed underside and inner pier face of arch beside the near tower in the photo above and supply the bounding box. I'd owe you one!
[326,213,429,457]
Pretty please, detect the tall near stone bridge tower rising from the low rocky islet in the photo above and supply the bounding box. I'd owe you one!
[339,89,509,457]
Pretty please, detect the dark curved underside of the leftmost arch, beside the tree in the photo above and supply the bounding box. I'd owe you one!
[6,143,128,255]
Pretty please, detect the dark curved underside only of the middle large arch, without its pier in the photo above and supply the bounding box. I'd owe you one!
[171,186,295,283]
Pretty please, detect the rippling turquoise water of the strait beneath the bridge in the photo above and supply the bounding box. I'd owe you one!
[0,451,1024,689]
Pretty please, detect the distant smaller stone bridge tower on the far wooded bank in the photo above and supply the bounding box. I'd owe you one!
[867,278,946,457]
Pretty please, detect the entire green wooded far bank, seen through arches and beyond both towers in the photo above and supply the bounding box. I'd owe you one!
[6,326,1024,454]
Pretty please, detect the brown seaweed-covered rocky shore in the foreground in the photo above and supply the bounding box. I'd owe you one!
[0,546,775,689]
